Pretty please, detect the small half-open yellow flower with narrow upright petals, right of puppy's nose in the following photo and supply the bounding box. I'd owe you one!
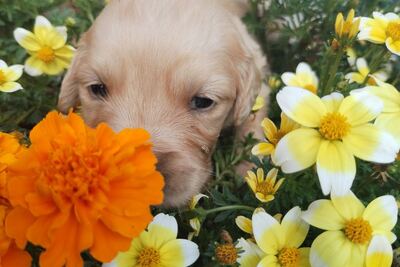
[245,168,285,203]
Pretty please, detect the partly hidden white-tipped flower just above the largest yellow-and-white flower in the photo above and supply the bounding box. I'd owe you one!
[281,62,318,94]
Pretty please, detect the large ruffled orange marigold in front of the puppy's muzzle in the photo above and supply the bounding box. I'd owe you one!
[6,112,164,267]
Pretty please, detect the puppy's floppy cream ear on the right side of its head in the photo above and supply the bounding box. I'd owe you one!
[233,19,266,126]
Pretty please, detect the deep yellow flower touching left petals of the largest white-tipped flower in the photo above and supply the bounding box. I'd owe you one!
[251,113,300,156]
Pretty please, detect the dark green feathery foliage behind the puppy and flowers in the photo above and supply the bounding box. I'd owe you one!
[0,0,400,267]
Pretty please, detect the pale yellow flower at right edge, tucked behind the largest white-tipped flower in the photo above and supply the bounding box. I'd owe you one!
[352,80,400,148]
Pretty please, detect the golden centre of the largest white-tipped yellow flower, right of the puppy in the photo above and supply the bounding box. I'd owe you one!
[319,112,350,140]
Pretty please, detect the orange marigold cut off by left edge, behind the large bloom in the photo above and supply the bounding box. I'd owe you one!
[0,133,31,267]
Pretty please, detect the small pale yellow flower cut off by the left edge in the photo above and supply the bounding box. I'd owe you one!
[0,59,24,93]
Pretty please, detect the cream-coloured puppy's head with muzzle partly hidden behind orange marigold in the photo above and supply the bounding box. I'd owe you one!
[59,0,261,206]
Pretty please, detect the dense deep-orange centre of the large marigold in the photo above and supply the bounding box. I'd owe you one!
[39,144,108,205]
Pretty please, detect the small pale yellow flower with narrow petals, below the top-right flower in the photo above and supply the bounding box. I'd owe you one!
[345,57,388,85]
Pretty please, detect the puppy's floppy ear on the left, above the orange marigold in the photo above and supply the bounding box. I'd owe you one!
[58,49,81,113]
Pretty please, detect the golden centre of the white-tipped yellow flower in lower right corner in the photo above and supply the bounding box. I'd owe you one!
[344,218,372,244]
